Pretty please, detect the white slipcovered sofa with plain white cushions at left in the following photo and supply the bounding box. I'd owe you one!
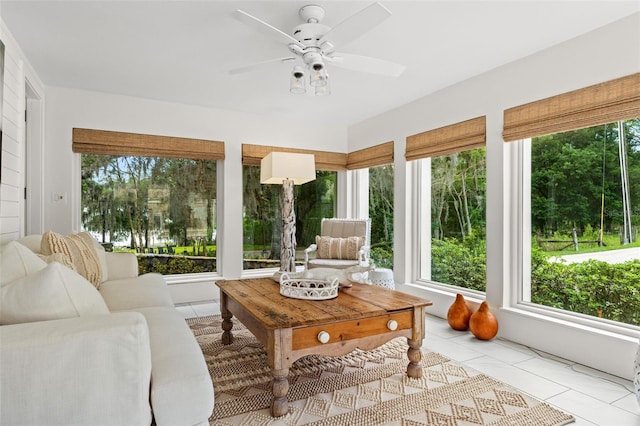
[0,234,214,426]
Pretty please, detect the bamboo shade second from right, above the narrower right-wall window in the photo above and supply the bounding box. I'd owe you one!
[405,116,487,161]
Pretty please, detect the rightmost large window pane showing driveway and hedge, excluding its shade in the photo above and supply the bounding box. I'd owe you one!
[522,118,640,325]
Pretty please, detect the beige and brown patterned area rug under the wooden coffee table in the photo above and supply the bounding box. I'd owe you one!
[187,315,574,426]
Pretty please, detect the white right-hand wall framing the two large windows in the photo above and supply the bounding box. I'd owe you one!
[348,14,640,377]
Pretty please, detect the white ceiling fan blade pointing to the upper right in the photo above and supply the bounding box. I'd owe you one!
[319,3,391,47]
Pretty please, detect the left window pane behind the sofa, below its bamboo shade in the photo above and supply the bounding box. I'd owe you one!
[81,154,217,274]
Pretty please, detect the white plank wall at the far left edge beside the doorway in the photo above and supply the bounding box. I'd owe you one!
[0,20,44,244]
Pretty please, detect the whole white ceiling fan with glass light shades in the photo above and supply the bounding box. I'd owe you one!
[229,3,405,95]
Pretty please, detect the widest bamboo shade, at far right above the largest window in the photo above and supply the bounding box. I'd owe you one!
[502,73,640,142]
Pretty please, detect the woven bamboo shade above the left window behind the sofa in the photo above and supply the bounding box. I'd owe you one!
[72,128,224,160]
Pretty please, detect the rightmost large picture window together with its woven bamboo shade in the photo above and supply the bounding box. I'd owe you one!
[502,73,640,326]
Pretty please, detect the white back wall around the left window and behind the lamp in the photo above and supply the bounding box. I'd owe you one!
[44,87,347,278]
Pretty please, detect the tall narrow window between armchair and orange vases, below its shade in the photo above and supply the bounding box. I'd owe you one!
[420,148,487,291]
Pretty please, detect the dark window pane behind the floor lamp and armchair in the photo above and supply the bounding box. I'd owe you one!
[242,165,337,270]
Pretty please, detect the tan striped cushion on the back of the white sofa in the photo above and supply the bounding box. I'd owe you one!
[40,231,102,288]
